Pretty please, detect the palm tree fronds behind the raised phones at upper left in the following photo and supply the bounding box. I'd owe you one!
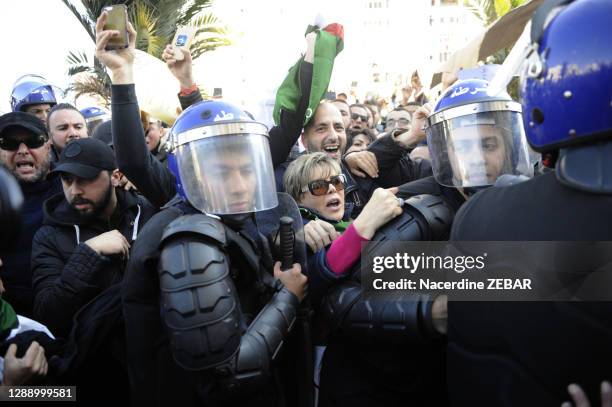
[62,0,231,104]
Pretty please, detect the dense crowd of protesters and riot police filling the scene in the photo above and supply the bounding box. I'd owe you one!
[0,0,612,407]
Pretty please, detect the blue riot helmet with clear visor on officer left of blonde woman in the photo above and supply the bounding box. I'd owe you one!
[167,100,278,215]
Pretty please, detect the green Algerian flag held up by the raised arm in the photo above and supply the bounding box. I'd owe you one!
[274,23,344,125]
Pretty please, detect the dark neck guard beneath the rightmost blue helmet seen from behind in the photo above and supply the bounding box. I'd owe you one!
[555,140,612,195]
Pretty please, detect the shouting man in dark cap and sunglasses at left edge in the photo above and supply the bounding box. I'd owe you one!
[0,112,61,317]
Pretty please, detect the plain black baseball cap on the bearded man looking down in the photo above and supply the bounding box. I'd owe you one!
[51,138,116,179]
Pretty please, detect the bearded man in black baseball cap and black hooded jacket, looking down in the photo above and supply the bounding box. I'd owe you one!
[32,138,155,336]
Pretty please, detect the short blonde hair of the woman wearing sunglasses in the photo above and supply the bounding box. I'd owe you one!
[283,153,342,202]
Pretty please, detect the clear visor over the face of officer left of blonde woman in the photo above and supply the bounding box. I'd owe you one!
[176,134,278,215]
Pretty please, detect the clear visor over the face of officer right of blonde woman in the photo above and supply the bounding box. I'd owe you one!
[427,111,533,188]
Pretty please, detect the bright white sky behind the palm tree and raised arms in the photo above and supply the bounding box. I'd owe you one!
[0,0,478,122]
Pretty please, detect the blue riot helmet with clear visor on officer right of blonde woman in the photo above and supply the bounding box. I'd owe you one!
[426,79,533,188]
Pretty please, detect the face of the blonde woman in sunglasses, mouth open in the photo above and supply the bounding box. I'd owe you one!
[299,169,344,221]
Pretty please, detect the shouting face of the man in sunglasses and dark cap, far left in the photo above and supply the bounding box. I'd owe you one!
[0,128,51,183]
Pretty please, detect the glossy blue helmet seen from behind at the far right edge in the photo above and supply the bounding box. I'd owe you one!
[521,0,612,152]
